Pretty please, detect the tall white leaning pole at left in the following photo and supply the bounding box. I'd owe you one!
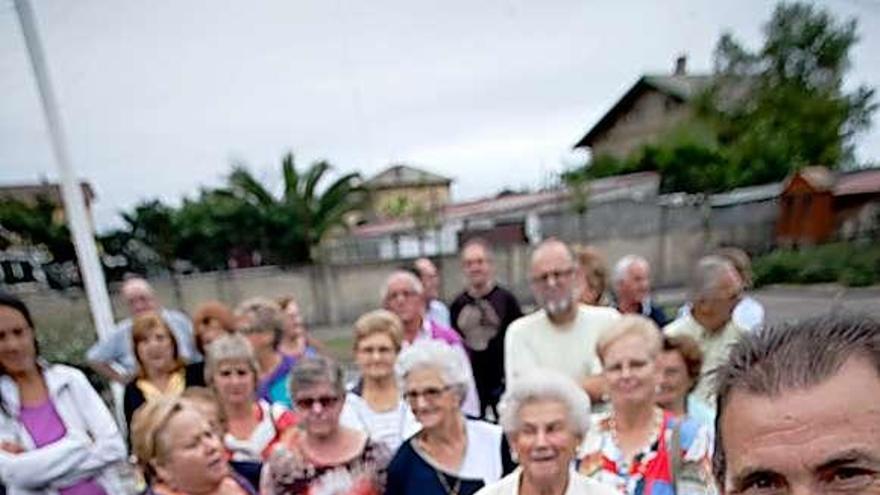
[15,0,113,339]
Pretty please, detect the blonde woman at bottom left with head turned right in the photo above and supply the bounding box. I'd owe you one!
[131,397,256,495]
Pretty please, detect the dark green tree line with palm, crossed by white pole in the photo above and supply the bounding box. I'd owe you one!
[0,153,368,286]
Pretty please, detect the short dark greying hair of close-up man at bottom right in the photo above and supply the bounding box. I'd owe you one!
[712,314,880,484]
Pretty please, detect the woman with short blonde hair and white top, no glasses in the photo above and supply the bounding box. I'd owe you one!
[339,309,419,452]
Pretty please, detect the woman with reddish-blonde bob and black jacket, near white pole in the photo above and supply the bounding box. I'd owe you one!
[123,312,205,424]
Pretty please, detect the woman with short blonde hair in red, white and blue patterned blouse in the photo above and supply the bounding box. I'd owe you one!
[580,315,712,495]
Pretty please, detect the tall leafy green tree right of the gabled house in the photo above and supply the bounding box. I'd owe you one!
[699,3,877,181]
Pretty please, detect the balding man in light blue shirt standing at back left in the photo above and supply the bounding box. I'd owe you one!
[86,278,201,384]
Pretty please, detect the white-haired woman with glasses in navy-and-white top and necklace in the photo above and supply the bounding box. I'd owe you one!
[385,340,514,495]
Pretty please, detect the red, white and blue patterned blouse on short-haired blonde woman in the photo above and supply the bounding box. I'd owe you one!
[578,411,715,495]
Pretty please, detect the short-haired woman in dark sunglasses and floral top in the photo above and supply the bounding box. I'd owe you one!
[260,357,390,495]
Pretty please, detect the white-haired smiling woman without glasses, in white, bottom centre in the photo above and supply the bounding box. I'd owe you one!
[477,369,617,495]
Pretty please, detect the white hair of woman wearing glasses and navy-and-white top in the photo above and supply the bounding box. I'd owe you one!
[394,340,471,401]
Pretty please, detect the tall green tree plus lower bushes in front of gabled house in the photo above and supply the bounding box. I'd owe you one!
[563,3,877,194]
